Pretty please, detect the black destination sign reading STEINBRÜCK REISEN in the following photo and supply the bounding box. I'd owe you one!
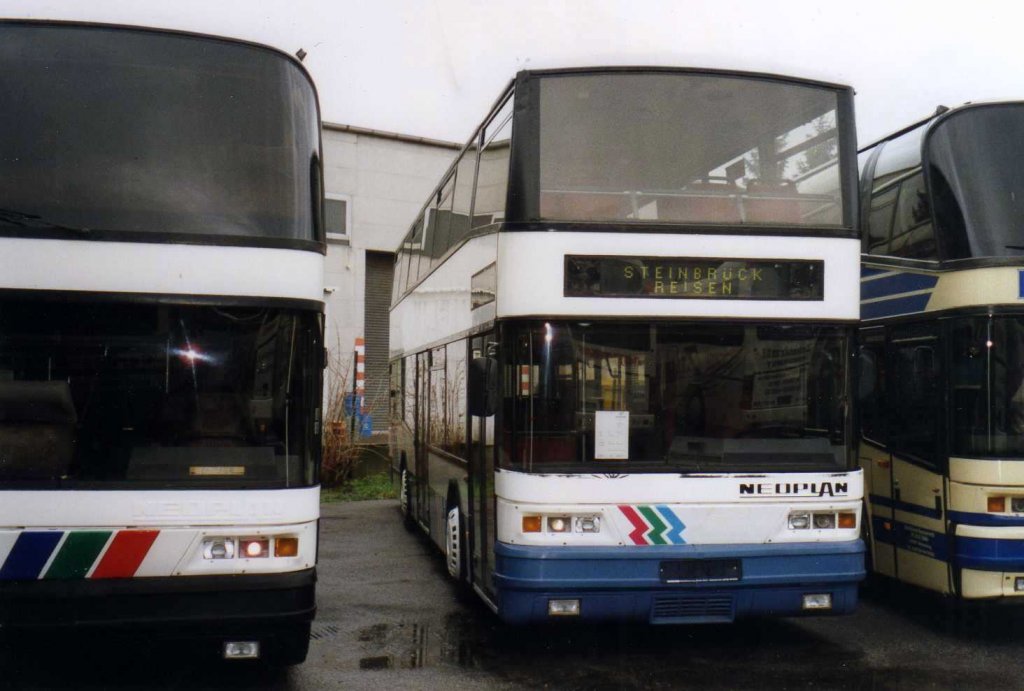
[564,255,824,300]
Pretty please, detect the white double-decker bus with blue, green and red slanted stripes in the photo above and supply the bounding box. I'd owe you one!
[0,21,325,663]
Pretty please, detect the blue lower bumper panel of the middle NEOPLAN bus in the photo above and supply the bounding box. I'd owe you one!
[494,539,864,623]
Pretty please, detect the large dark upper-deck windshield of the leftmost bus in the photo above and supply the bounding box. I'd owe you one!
[0,24,321,245]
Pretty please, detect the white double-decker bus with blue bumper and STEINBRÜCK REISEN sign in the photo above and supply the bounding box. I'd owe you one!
[391,68,864,623]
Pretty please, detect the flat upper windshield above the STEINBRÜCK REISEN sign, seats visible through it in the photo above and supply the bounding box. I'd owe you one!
[539,72,855,226]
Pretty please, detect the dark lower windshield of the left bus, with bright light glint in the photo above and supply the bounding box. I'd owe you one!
[0,299,321,488]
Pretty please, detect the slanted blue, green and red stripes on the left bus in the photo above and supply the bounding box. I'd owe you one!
[0,530,160,580]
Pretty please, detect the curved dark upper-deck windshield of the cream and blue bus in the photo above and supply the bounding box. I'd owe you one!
[925,103,1024,259]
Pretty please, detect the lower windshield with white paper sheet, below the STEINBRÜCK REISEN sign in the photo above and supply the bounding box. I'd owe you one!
[500,321,852,472]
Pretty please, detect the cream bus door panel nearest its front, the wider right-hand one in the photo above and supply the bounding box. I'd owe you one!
[889,322,951,593]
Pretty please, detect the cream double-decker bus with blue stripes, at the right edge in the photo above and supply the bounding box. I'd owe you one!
[858,102,1024,604]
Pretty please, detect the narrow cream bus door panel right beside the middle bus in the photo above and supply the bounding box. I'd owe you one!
[857,329,896,577]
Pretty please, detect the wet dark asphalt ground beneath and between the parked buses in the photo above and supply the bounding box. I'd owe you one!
[6,502,1024,690]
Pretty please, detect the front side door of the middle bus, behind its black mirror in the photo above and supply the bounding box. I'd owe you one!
[467,333,497,599]
